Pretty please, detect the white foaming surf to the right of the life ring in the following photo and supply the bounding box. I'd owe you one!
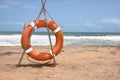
[65,36,120,46]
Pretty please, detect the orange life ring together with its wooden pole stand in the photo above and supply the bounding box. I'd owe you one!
[18,0,63,65]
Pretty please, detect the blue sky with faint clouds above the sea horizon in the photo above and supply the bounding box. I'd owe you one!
[0,0,120,32]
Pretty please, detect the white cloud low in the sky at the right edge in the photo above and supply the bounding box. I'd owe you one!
[102,18,120,26]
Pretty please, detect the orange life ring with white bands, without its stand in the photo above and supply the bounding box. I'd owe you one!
[21,19,63,61]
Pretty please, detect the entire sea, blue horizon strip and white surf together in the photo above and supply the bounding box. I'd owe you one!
[0,32,120,46]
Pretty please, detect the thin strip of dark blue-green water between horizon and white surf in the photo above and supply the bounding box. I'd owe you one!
[0,32,120,36]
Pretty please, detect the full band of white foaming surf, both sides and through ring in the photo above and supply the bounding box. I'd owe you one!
[0,34,120,46]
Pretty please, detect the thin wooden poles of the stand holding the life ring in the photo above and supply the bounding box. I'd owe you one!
[18,0,56,66]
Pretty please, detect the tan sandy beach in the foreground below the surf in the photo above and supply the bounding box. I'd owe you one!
[0,46,120,80]
